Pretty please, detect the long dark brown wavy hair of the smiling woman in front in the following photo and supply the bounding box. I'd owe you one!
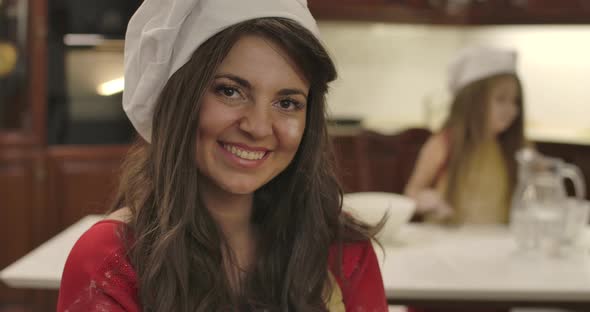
[114,18,378,312]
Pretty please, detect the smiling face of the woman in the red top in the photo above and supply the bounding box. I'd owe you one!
[196,35,310,194]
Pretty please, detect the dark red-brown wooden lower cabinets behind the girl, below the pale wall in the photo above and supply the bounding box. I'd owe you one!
[332,128,590,199]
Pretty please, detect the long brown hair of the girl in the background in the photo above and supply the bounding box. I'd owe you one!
[442,74,525,221]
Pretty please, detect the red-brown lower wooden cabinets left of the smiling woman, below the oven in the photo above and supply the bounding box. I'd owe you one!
[0,146,127,311]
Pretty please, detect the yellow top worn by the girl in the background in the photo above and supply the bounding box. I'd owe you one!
[436,140,511,224]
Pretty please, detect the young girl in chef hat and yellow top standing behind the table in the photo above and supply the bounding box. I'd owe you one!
[405,46,525,224]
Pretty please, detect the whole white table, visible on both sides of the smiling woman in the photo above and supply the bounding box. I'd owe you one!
[0,215,590,311]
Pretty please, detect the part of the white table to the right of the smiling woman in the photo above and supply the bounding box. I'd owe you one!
[376,225,590,311]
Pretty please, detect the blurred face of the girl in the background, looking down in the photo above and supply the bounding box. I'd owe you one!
[488,76,520,135]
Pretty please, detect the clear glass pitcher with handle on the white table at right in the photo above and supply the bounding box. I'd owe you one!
[510,148,586,253]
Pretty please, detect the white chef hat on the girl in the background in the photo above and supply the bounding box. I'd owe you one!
[449,46,516,94]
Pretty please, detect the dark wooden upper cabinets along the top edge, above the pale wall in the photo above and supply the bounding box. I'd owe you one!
[308,0,590,25]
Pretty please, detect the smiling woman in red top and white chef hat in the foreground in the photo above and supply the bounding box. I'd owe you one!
[58,0,387,312]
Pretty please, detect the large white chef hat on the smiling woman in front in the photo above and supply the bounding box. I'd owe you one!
[123,0,319,142]
